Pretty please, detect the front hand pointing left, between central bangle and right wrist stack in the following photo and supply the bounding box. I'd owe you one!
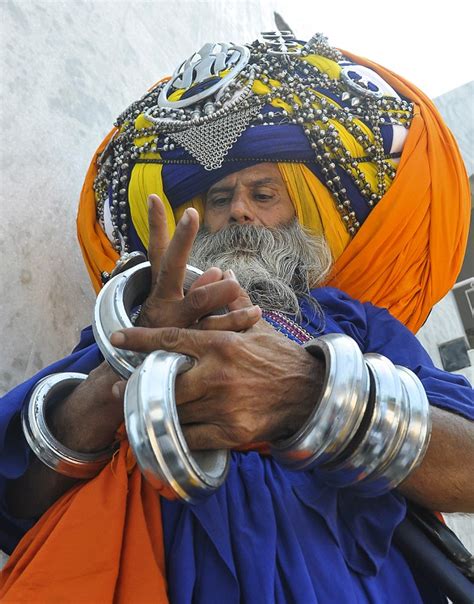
[111,321,324,450]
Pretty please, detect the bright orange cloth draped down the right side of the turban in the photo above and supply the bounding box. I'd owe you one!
[329,53,470,332]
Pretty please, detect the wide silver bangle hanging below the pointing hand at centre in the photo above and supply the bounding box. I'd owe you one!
[125,350,230,503]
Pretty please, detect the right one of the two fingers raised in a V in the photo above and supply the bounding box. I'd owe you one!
[154,208,199,300]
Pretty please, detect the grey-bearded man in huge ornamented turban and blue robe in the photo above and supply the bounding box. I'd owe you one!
[1,36,474,602]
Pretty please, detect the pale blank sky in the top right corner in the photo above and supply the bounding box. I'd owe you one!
[271,0,474,101]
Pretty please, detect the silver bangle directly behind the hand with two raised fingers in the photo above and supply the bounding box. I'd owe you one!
[92,254,227,379]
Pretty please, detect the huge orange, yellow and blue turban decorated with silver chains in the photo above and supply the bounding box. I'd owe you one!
[78,36,470,331]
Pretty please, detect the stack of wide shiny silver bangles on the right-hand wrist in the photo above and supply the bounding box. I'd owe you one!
[272,334,431,497]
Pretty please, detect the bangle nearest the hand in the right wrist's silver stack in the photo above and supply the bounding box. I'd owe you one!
[271,334,369,470]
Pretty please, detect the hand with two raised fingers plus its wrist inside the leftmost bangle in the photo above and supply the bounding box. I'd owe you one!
[51,195,261,452]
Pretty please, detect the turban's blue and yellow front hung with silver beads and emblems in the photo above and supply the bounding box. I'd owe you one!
[92,32,413,252]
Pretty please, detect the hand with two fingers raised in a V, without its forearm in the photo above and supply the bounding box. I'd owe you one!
[137,195,261,330]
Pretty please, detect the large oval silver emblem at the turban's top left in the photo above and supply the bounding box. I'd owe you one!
[158,42,250,109]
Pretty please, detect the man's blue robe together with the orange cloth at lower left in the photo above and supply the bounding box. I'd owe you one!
[0,288,474,604]
